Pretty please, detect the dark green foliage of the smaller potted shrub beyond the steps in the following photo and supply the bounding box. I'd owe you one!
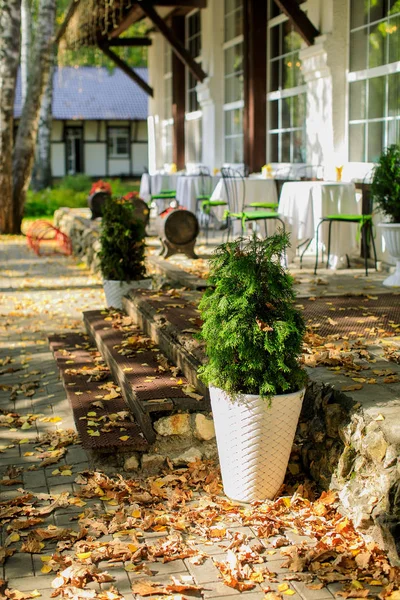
[99,198,146,282]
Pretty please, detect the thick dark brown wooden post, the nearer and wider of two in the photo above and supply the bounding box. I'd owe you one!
[243,0,267,172]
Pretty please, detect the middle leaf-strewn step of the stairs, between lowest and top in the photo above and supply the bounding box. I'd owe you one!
[84,310,209,443]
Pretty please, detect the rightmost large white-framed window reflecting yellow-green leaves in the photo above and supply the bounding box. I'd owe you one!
[348,0,400,162]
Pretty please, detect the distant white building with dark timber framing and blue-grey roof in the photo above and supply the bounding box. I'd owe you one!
[15,67,148,178]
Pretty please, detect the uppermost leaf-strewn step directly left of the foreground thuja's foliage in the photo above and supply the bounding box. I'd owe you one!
[123,290,209,398]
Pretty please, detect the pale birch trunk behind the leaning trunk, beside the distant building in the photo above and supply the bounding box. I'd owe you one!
[31,58,54,191]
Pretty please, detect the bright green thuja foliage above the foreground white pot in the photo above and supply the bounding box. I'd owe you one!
[199,234,306,397]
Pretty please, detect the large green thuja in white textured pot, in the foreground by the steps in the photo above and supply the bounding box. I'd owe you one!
[199,233,306,502]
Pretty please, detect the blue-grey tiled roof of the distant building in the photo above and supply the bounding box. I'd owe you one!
[14,67,148,120]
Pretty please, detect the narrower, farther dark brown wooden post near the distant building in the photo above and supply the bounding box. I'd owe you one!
[171,17,186,170]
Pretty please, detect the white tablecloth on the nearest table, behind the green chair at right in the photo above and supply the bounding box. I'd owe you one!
[278,181,361,267]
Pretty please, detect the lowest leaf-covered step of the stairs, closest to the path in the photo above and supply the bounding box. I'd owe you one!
[49,333,148,451]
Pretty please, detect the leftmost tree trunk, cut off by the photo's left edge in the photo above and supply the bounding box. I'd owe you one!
[0,0,21,233]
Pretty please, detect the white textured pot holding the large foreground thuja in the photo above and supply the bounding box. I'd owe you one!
[210,387,305,502]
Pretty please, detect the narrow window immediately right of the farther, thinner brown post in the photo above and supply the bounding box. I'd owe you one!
[185,10,202,163]
